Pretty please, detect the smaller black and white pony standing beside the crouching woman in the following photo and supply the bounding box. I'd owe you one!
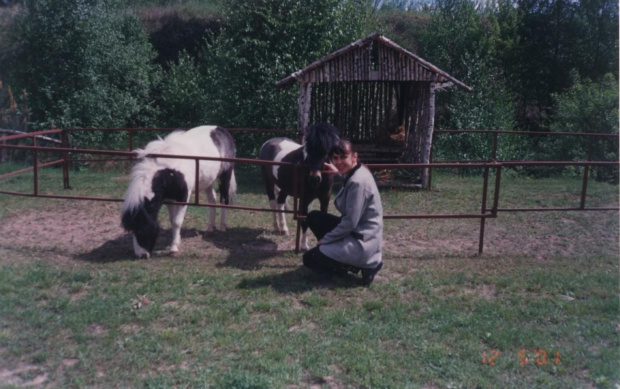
[258,124,339,251]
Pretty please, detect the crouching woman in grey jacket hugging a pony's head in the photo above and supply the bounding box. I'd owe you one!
[303,139,383,285]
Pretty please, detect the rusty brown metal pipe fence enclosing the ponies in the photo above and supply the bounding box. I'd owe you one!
[0,128,620,254]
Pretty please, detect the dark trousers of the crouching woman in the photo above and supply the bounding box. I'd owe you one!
[303,211,358,273]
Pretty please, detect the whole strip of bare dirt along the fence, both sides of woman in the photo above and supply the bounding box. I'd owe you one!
[0,196,618,268]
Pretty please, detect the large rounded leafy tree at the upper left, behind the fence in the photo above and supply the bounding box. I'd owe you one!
[11,0,159,147]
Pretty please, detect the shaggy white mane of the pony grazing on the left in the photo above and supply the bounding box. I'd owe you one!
[122,131,184,212]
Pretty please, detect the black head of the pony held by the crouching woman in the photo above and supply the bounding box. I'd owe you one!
[303,124,339,187]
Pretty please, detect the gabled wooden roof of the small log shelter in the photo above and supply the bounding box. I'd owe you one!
[276,33,472,91]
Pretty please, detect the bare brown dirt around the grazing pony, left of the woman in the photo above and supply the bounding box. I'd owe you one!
[0,201,278,262]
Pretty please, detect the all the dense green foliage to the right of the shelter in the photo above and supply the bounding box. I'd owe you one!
[385,0,618,181]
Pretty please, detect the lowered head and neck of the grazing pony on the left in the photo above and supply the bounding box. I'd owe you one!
[121,158,188,259]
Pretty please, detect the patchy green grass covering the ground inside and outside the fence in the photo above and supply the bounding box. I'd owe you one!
[0,164,620,388]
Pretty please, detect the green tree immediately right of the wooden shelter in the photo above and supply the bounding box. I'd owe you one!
[420,0,519,160]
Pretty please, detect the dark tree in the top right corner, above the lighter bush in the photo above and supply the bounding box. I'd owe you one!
[498,0,618,131]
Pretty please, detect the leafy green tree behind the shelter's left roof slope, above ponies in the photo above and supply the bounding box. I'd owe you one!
[194,0,372,152]
